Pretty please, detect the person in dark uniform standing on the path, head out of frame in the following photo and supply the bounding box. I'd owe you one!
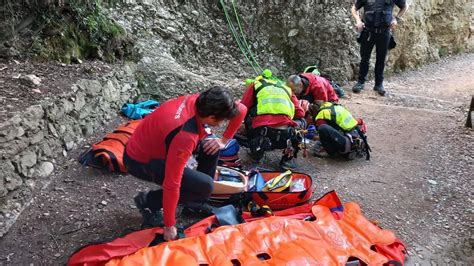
[352,0,408,96]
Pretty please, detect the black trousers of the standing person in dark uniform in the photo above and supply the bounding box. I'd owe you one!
[359,28,391,85]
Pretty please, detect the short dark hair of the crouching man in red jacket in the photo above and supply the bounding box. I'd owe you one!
[196,86,238,119]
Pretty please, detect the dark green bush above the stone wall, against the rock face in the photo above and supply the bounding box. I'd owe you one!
[35,0,133,62]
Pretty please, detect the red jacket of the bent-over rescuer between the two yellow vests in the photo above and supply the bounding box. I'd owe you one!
[298,73,339,103]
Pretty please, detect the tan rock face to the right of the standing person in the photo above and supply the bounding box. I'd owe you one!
[389,0,474,71]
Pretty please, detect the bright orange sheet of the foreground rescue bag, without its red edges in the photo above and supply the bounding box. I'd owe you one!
[106,203,395,266]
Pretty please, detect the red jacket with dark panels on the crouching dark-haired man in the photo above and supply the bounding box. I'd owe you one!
[127,94,247,226]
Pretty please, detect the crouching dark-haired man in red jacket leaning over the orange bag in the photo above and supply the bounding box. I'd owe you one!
[124,86,247,240]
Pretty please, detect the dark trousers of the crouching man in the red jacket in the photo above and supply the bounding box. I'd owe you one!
[124,145,219,211]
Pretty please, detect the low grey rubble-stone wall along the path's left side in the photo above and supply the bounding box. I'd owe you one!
[0,65,137,236]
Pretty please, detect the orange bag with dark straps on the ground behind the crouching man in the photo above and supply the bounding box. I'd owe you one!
[79,120,142,173]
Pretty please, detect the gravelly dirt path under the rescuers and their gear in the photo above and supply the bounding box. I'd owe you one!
[0,54,474,265]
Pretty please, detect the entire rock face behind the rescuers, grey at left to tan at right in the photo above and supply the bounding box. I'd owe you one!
[105,0,474,98]
